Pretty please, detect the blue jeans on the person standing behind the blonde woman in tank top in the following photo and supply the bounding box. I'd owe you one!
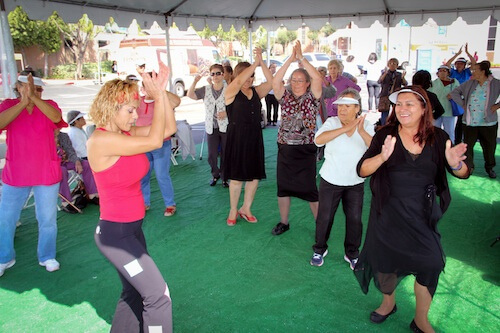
[141,140,175,207]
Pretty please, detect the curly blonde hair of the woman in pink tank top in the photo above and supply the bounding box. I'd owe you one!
[89,79,139,127]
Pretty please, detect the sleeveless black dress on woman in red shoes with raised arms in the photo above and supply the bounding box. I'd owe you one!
[224,87,266,181]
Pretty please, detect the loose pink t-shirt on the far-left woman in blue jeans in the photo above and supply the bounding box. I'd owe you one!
[0,99,62,186]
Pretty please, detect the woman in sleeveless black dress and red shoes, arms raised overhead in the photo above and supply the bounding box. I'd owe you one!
[224,49,273,226]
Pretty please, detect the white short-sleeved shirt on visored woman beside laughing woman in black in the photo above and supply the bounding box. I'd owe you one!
[314,117,375,186]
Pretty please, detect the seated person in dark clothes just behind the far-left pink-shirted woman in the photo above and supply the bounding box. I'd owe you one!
[55,129,99,214]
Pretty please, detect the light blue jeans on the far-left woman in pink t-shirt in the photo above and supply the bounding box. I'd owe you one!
[0,183,59,264]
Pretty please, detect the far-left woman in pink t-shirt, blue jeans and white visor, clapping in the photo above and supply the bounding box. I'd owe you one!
[0,73,67,276]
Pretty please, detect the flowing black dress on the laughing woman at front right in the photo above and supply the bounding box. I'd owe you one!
[354,127,456,295]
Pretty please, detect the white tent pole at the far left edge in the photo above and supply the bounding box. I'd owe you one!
[0,0,17,98]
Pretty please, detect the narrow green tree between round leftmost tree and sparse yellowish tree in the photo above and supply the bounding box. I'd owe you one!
[36,11,62,77]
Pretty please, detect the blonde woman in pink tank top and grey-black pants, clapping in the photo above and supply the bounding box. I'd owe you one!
[87,61,176,332]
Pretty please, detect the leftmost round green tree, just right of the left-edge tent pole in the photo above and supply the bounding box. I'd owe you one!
[8,6,37,63]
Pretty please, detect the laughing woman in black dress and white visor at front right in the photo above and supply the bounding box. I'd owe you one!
[355,86,469,332]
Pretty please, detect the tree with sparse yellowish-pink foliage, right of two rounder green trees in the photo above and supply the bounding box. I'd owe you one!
[54,14,99,79]
